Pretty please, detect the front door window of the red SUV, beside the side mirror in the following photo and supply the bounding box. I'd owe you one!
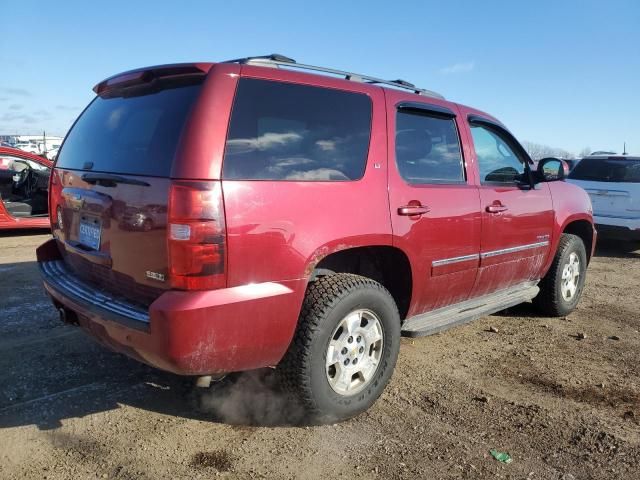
[471,125,524,183]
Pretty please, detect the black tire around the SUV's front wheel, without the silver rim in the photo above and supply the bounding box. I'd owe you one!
[533,233,587,317]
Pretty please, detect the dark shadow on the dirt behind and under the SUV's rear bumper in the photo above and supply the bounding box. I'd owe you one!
[0,261,303,435]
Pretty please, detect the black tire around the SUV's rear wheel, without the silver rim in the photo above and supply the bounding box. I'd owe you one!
[277,274,400,423]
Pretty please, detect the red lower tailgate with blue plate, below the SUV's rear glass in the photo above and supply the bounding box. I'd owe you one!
[55,174,169,305]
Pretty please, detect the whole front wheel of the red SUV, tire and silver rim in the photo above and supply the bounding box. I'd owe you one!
[533,233,587,317]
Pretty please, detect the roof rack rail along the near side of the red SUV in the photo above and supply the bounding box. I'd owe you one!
[222,53,444,100]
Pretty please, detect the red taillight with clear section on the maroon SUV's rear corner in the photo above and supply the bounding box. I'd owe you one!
[167,181,226,290]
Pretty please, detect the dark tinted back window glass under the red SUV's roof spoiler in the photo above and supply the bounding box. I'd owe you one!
[57,80,201,177]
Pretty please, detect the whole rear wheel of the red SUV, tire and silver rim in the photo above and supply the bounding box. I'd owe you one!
[278,274,400,422]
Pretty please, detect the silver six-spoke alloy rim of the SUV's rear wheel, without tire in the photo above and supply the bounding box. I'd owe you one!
[325,309,384,396]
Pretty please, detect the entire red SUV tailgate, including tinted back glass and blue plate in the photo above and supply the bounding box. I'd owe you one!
[51,75,202,305]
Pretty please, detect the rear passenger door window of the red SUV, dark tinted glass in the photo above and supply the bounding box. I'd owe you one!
[396,110,465,184]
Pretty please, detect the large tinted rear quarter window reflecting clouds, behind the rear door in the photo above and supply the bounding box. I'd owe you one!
[223,79,371,181]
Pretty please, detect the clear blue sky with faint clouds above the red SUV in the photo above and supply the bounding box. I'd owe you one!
[0,0,640,154]
